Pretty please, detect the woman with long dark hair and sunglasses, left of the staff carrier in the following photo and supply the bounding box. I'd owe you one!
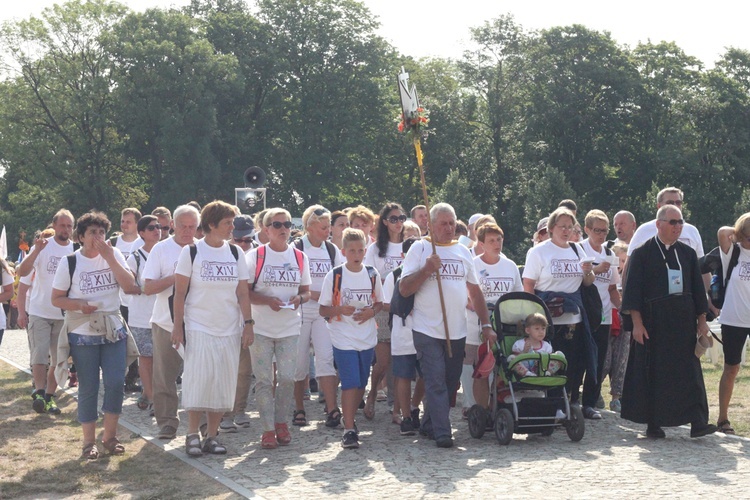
[364,203,407,419]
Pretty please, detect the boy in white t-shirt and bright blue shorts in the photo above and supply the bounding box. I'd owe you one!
[318,228,383,448]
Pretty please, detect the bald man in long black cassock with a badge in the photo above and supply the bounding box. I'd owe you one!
[622,205,716,438]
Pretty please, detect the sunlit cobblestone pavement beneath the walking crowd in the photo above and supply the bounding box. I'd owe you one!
[0,330,750,498]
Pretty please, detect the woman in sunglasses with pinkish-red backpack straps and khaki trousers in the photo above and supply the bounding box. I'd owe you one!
[247,208,312,449]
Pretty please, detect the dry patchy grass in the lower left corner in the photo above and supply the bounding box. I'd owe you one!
[0,361,238,499]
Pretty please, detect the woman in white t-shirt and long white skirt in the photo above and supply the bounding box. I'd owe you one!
[172,201,253,456]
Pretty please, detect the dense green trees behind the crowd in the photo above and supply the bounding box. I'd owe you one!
[0,0,750,261]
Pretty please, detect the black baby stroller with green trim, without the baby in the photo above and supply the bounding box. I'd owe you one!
[468,292,585,445]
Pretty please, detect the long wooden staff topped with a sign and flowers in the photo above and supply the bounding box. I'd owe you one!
[398,66,453,358]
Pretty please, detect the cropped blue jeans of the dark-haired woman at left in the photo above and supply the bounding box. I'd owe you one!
[70,340,127,424]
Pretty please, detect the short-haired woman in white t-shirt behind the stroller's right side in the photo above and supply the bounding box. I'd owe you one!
[523,207,601,418]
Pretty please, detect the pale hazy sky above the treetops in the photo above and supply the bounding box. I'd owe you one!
[5,0,750,67]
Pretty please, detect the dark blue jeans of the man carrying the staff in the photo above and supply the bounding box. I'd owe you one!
[413,330,466,439]
